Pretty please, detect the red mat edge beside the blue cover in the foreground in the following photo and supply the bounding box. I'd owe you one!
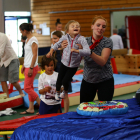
[0,113,63,131]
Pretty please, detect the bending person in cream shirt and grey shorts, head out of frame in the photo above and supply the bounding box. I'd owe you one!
[0,32,25,98]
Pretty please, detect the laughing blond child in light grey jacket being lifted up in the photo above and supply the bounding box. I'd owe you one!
[47,20,91,112]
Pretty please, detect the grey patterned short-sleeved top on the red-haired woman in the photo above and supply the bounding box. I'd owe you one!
[83,37,113,83]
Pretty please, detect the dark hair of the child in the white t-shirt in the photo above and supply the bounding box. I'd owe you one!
[40,55,56,70]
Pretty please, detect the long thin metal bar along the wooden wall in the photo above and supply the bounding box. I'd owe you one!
[49,7,140,14]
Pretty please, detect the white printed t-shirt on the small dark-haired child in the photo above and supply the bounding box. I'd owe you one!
[38,71,61,105]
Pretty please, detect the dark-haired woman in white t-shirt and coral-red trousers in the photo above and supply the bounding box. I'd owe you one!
[19,23,40,114]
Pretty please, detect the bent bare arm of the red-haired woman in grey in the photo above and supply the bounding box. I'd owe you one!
[90,48,111,66]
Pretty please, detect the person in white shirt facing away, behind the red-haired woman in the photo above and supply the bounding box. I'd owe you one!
[110,29,124,50]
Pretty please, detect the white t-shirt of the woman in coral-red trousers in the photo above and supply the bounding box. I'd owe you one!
[24,36,38,68]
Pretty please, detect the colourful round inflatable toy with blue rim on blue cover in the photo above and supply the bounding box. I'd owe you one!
[76,101,128,116]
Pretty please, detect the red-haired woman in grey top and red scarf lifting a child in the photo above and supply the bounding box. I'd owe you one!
[62,16,114,103]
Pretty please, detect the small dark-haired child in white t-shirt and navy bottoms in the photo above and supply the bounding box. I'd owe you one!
[38,55,62,115]
